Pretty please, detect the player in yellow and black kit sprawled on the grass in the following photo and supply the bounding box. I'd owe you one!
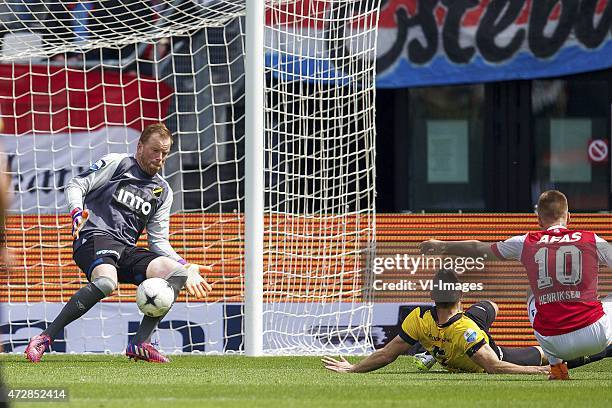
[323,270,550,374]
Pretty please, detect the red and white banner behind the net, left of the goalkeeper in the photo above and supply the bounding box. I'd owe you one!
[0,65,172,213]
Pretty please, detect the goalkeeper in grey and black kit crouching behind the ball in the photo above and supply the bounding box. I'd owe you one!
[25,123,211,363]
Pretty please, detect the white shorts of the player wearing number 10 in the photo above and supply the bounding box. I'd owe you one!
[527,296,612,364]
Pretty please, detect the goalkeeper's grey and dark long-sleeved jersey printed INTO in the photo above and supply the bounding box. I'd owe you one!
[66,154,180,259]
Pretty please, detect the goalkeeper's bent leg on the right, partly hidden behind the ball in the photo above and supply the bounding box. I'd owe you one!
[125,257,187,363]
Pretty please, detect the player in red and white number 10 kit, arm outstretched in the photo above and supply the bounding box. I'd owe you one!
[421,190,612,379]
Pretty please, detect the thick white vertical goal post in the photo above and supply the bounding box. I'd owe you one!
[244,0,265,356]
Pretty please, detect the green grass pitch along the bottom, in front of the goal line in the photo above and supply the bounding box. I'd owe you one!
[0,355,612,408]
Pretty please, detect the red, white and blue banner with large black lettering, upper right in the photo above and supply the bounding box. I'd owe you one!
[267,0,612,88]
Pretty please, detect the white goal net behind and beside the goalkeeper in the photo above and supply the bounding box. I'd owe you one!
[0,0,379,354]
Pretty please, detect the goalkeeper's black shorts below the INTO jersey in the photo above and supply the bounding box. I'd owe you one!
[72,235,161,285]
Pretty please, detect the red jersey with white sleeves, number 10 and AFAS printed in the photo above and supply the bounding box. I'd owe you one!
[491,225,612,336]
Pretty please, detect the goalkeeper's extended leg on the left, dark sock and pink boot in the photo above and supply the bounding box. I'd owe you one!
[25,264,117,363]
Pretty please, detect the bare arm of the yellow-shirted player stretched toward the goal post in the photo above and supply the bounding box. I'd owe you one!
[321,336,412,373]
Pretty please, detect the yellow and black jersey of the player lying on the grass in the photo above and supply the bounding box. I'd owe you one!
[399,307,491,373]
